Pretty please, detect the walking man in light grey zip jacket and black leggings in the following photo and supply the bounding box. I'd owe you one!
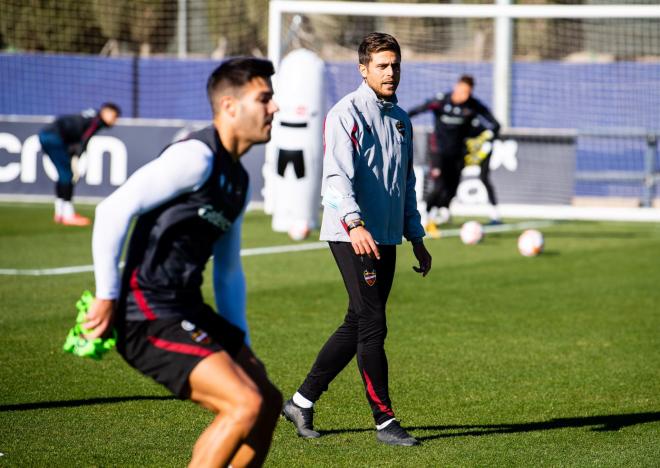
[283,33,431,446]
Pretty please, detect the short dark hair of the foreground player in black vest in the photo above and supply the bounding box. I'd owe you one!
[206,57,275,112]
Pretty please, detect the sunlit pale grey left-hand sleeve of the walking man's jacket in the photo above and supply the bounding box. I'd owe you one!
[323,112,361,222]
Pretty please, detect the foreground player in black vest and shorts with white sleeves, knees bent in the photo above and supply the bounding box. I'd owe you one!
[84,58,282,467]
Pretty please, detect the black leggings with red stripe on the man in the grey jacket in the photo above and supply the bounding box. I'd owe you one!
[298,242,396,424]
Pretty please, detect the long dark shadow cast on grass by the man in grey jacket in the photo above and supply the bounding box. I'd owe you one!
[319,412,660,441]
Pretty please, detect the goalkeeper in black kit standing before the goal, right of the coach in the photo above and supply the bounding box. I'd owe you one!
[408,75,500,232]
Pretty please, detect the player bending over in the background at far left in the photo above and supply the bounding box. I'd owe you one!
[39,102,121,226]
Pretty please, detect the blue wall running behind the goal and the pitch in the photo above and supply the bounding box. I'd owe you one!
[0,54,660,196]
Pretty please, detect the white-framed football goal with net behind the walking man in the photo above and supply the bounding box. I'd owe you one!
[268,0,660,221]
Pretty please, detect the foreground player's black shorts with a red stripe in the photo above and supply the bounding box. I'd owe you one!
[117,305,245,399]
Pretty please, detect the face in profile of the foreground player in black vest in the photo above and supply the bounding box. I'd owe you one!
[235,77,279,144]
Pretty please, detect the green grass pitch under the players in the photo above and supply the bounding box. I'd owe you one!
[0,204,660,467]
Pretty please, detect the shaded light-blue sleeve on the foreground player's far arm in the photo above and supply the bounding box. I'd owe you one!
[213,208,250,346]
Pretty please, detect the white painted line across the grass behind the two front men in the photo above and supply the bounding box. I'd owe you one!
[0,221,556,276]
